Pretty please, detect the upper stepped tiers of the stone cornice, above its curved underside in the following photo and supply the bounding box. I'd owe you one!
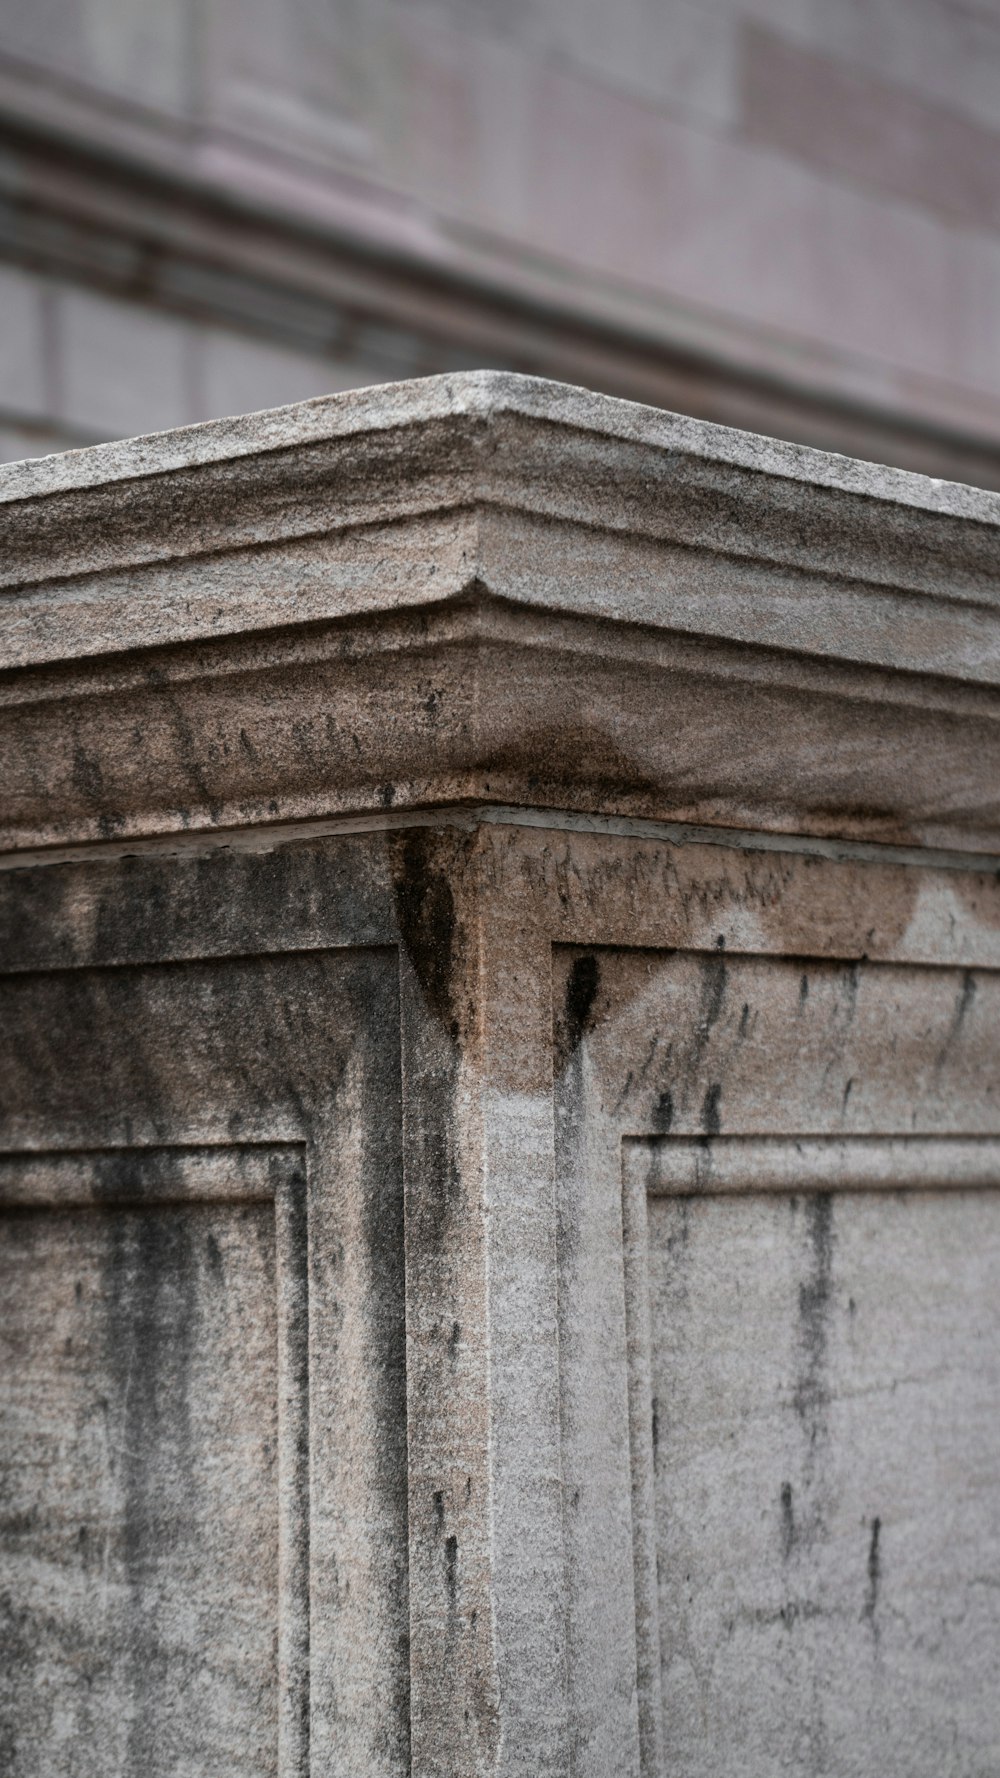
[0,372,1000,700]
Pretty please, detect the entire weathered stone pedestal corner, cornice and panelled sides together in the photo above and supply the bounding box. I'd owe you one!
[0,375,1000,1778]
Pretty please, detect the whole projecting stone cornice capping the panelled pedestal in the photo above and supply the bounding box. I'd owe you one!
[0,373,1000,850]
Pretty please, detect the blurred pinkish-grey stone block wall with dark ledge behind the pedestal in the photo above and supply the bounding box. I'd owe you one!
[0,0,1000,487]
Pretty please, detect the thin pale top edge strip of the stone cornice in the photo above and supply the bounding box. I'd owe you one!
[0,370,1000,525]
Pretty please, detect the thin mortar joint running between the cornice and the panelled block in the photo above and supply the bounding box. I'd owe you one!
[0,804,1000,874]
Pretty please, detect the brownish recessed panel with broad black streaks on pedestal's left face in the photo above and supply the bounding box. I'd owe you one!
[0,1149,308,1778]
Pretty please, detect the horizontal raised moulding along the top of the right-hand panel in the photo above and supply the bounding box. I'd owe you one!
[623,1131,1000,1197]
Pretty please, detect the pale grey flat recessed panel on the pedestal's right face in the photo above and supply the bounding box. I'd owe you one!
[633,1191,1000,1778]
